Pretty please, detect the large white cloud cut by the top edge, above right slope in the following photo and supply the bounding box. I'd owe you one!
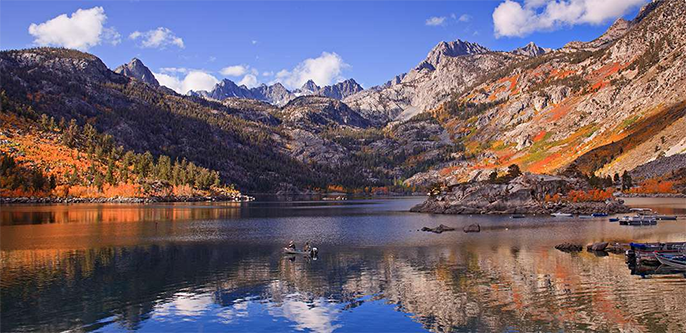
[493,0,648,38]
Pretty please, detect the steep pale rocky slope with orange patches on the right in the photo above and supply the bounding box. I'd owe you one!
[404,0,686,187]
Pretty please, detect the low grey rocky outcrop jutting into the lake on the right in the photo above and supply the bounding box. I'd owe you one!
[410,174,629,215]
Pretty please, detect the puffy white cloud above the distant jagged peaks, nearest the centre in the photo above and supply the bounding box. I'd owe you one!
[275,52,350,89]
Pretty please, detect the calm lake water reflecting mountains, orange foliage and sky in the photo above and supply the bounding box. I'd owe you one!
[0,198,686,332]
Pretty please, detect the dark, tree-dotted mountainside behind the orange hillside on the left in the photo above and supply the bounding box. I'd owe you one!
[0,48,446,193]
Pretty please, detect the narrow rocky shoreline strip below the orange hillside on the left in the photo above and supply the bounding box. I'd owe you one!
[0,194,255,205]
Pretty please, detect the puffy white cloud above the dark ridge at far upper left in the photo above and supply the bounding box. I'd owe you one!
[29,7,121,51]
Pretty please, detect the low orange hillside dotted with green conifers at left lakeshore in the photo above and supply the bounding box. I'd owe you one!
[0,105,245,200]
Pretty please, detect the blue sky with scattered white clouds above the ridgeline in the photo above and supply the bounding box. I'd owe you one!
[0,0,646,90]
